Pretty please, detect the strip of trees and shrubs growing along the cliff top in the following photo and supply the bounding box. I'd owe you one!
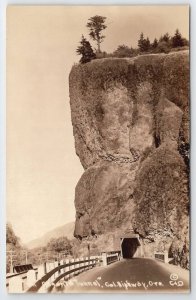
[77,16,189,64]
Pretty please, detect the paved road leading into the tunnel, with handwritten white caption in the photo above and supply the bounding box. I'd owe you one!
[54,258,188,293]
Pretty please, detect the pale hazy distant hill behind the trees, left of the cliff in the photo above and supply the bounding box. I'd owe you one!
[26,222,75,249]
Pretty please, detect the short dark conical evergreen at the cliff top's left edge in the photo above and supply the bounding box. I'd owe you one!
[76,35,96,64]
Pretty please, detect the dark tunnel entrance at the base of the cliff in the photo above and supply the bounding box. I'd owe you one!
[121,235,140,258]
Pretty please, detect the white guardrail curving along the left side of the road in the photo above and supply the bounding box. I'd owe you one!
[6,256,100,293]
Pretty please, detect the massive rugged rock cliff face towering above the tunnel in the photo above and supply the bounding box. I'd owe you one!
[70,51,189,262]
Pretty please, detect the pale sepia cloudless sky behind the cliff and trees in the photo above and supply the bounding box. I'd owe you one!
[6,5,189,243]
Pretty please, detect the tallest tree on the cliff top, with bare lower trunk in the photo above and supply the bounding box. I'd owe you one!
[86,15,107,53]
